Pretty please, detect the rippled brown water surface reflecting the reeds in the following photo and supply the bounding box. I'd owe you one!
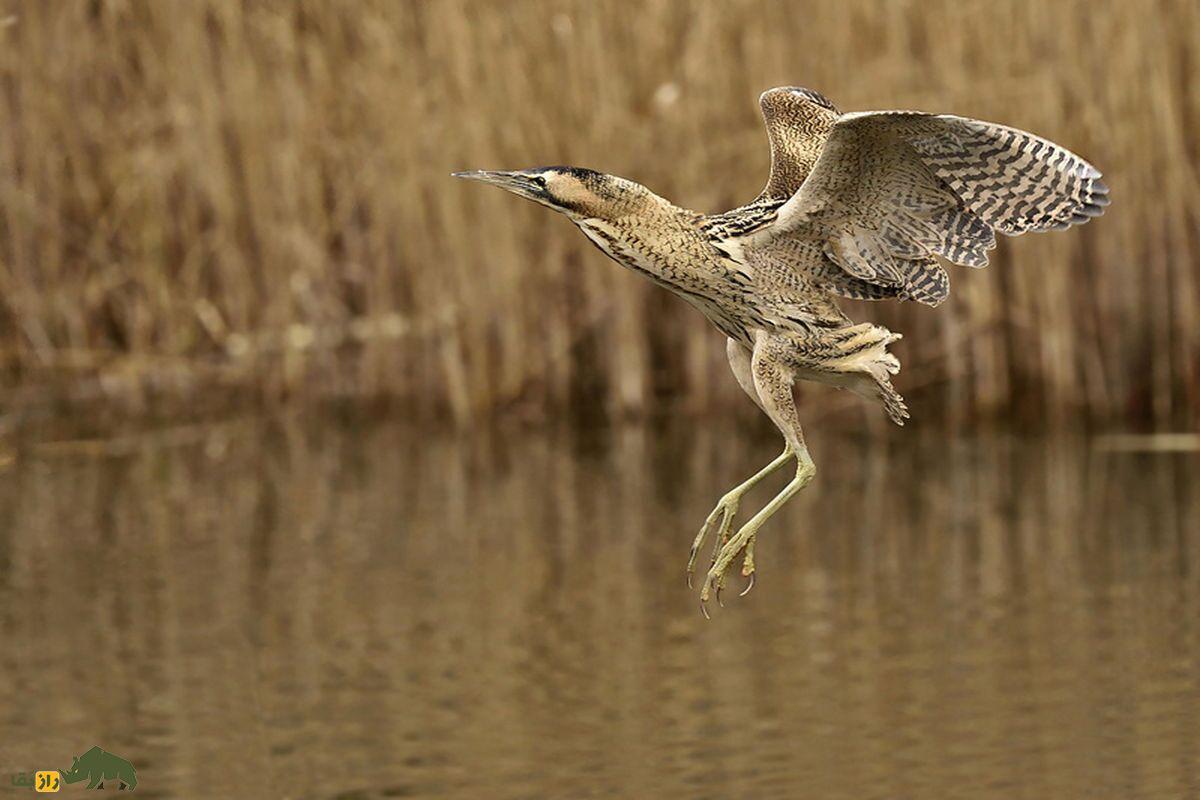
[0,422,1200,800]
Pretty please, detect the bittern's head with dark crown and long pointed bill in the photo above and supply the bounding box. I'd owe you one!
[454,167,648,221]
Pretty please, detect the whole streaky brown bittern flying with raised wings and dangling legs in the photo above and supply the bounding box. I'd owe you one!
[455,88,1109,616]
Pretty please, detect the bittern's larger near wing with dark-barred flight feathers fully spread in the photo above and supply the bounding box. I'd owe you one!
[752,112,1109,305]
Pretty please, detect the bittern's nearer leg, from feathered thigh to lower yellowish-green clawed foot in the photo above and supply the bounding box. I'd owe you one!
[700,332,816,616]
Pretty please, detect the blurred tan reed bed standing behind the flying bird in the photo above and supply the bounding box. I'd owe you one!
[0,0,1200,427]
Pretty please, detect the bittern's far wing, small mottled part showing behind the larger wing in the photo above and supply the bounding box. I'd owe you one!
[755,86,838,203]
